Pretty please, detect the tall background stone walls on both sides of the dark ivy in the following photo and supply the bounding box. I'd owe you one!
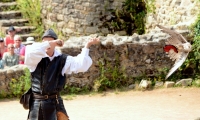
[42,0,200,37]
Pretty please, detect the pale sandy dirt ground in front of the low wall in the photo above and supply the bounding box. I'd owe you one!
[0,88,200,120]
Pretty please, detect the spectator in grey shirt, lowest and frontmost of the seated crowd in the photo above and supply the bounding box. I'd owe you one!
[2,44,19,68]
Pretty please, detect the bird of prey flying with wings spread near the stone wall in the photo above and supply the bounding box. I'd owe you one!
[157,25,192,79]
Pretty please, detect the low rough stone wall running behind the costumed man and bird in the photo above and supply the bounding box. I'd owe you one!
[0,29,189,91]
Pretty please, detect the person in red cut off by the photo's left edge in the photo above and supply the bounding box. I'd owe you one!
[0,37,7,69]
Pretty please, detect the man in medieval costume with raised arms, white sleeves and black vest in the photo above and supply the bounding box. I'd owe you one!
[25,29,100,120]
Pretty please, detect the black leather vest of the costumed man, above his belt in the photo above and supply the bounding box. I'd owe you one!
[31,54,67,95]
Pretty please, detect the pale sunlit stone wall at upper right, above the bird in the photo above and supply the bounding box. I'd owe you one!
[146,0,200,32]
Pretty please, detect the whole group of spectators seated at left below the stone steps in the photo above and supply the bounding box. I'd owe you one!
[0,26,35,69]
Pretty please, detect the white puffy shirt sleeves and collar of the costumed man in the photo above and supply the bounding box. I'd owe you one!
[24,41,92,75]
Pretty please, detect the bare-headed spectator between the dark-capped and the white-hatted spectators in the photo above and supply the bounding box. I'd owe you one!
[14,35,24,55]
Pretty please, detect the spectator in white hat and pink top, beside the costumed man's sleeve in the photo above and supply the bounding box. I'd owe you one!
[19,37,35,64]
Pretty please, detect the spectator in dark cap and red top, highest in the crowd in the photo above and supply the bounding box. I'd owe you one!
[4,26,17,46]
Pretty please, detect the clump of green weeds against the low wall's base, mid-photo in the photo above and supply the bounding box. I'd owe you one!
[93,53,127,91]
